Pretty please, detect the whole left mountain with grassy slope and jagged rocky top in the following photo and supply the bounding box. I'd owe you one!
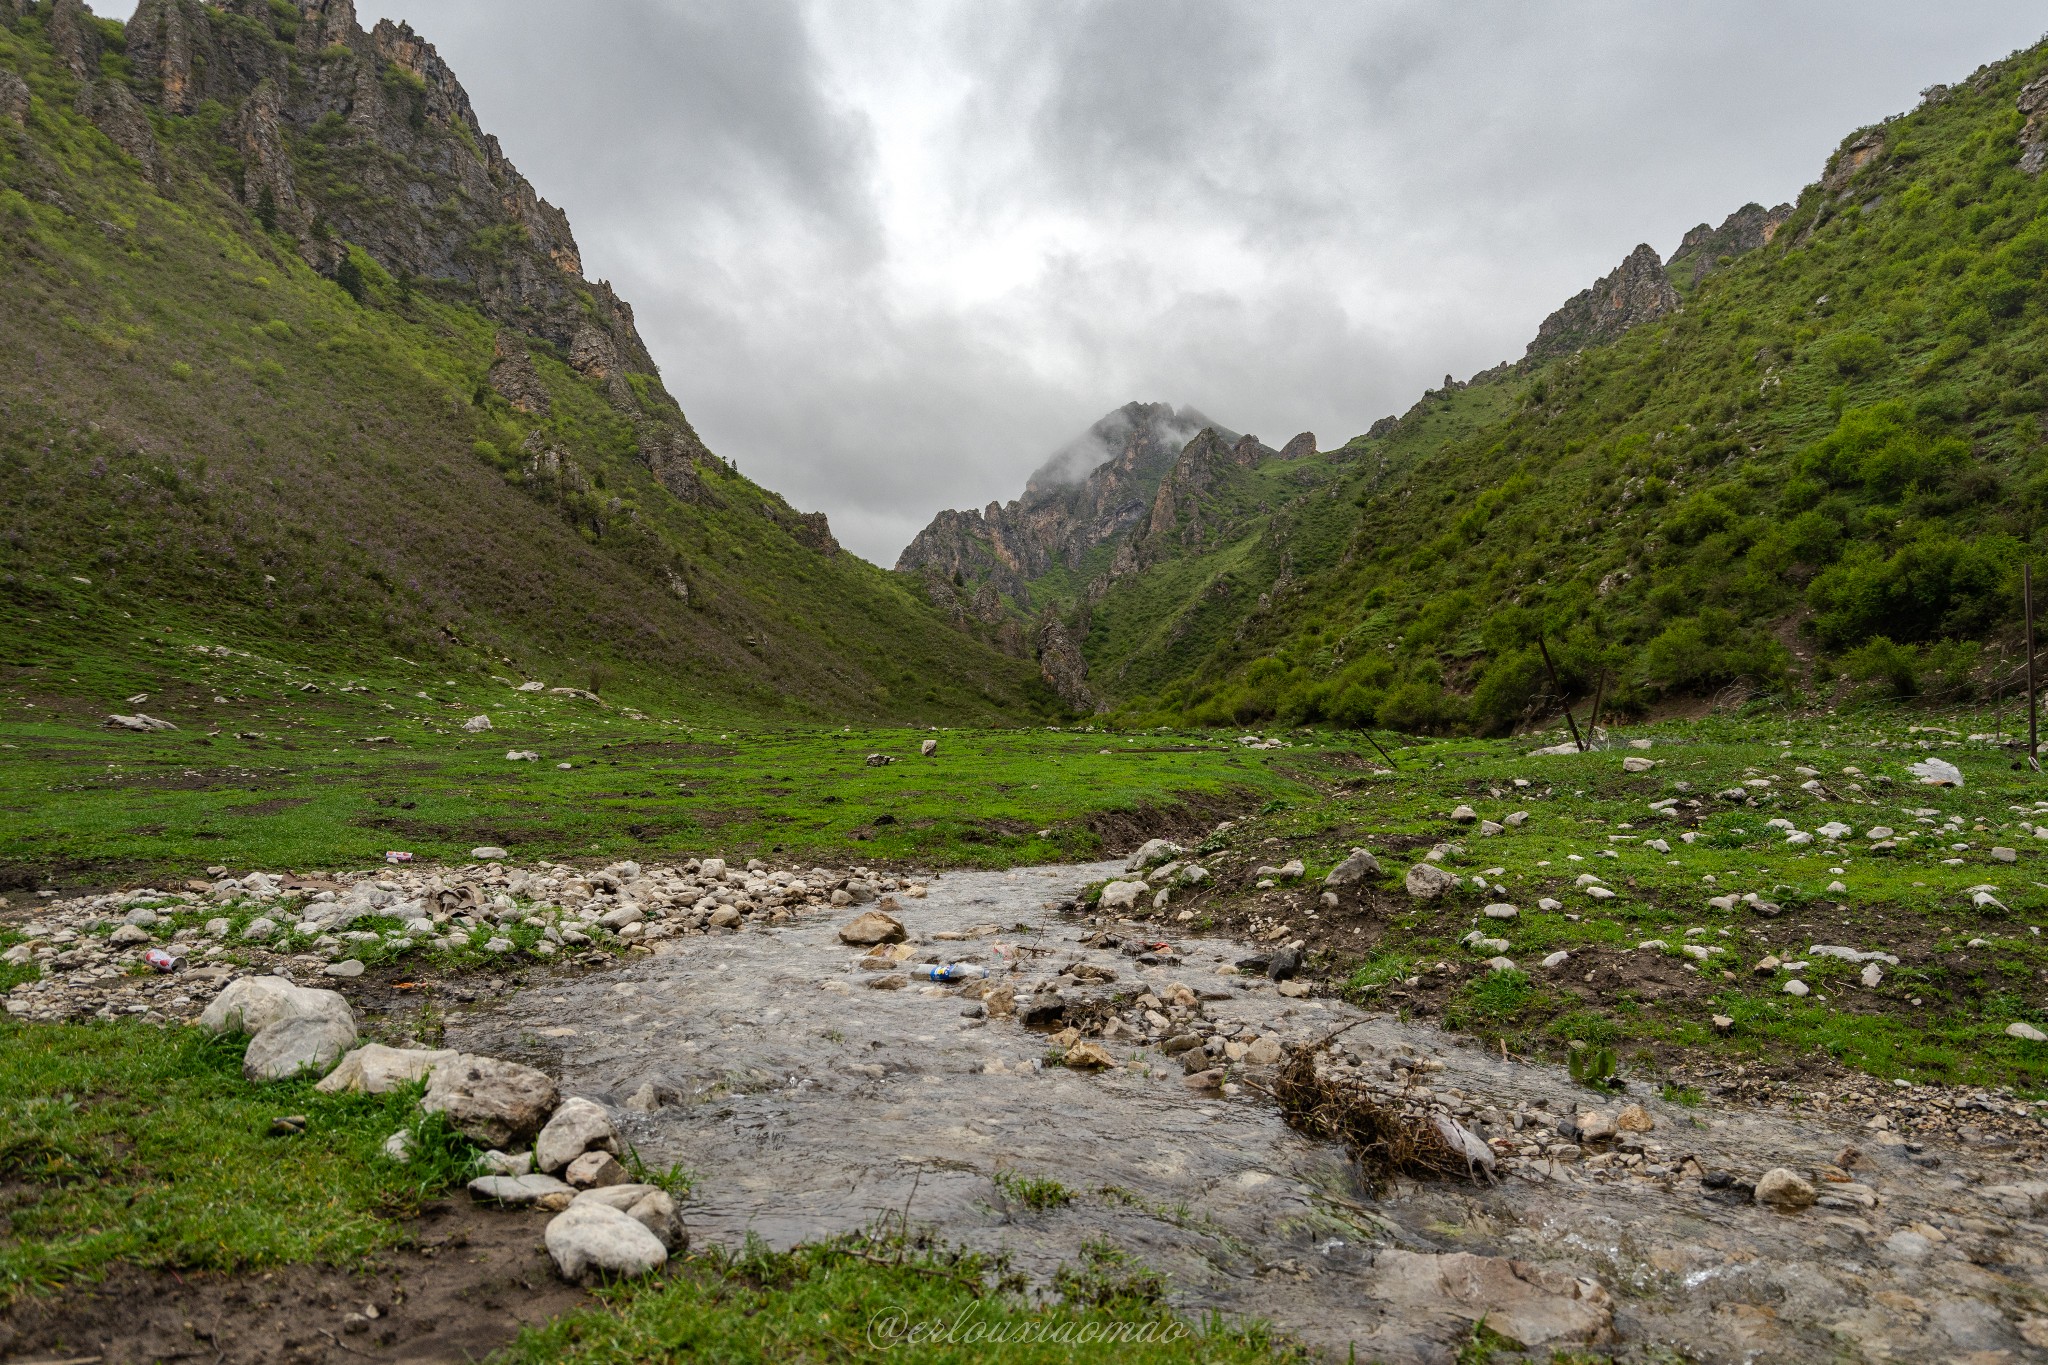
[0,0,1057,718]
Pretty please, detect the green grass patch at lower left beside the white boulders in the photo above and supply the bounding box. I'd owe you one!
[0,1021,471,1302]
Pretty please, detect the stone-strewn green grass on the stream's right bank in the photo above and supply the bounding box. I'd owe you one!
[1167,704,2048,1093]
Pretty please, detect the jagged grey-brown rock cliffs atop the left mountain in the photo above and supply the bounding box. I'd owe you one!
[39,0,778,523]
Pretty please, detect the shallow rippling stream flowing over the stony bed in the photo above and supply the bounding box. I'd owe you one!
[446,864,2048,1365]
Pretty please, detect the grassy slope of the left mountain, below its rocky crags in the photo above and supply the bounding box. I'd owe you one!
[0,6,1049,720]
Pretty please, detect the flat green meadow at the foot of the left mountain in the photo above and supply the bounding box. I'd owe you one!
[0,634,1307,884]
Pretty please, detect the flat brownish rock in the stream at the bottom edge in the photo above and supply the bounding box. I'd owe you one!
[1366,1250,1614,1359]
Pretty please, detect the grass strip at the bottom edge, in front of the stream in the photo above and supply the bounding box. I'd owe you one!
[504,1238,1305,1365]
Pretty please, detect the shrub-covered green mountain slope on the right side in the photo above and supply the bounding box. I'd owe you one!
[899,37,2048,733]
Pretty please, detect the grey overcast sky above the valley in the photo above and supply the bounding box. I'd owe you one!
[94,0,2048,565]
